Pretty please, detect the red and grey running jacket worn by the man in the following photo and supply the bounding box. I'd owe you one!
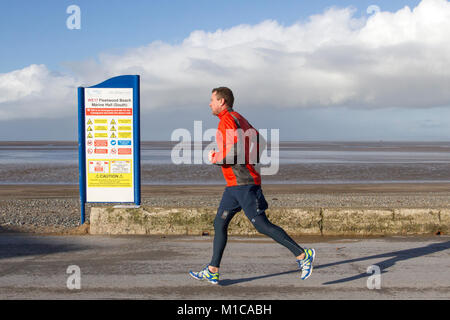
[211,109,264,186]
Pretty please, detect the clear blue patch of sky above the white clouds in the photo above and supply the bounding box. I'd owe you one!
[0,0,419,73]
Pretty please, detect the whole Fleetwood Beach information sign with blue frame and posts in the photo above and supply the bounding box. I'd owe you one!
[78,75,141,224]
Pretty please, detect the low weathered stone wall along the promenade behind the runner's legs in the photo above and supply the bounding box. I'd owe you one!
[90,206,450,236]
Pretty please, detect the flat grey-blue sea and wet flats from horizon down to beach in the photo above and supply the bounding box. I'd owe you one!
[0,141,450,185]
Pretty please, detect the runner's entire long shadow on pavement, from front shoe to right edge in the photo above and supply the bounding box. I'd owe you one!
[220,241,450,286]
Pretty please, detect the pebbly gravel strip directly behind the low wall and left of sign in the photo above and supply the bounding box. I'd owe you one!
[0,192,450,233]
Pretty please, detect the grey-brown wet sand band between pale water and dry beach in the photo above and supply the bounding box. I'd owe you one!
[0,162,450,185]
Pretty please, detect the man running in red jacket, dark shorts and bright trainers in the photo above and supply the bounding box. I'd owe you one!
[189,87,315,284]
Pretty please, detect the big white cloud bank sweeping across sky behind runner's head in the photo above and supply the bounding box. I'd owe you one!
[0,0,450,119]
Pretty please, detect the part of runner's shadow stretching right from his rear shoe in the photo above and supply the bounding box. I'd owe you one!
[315,241,450,285]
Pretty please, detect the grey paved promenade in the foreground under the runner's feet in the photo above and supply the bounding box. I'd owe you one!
[0,234,450,300]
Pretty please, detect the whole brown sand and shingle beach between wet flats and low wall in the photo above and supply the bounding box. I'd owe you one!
[0,183,450,233]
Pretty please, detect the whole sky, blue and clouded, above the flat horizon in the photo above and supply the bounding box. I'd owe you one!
[0,0,450,141]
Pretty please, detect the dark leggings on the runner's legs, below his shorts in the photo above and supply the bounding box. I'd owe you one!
[210,211,304,267]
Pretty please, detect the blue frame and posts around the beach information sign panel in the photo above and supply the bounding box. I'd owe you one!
[78,75,141,224]
